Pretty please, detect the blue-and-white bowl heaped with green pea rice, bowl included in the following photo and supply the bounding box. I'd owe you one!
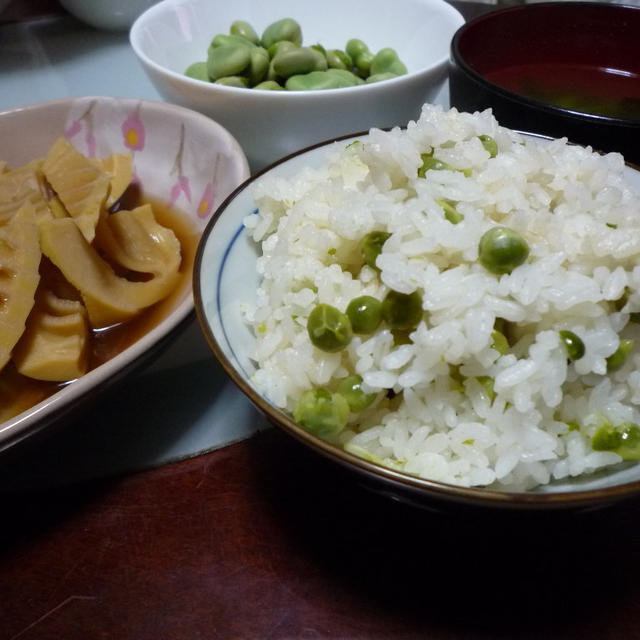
[194,104,640,508]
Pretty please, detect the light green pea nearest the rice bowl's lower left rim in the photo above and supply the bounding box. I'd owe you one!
[293,389,350,438]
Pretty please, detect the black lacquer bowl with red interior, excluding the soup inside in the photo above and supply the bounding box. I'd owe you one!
[449,2,640,164]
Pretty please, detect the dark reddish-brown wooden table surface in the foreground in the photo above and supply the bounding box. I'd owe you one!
[0,430,640,640]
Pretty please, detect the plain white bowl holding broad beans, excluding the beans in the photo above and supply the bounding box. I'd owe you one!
[130,0,464,170]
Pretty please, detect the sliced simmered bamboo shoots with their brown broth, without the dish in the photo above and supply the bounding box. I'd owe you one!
[0,138,198,422]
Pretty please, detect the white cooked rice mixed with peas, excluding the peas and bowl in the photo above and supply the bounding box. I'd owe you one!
[245,105,640,490]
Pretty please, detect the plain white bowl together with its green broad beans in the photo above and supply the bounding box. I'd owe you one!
[130,0,464,170]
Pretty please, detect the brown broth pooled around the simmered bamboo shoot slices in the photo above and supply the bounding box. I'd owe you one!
[0,192,199,422]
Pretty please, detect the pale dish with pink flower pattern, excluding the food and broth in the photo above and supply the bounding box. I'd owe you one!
[0,96,249,452]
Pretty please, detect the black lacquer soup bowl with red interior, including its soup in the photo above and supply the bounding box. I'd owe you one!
[449,2,640,164]
